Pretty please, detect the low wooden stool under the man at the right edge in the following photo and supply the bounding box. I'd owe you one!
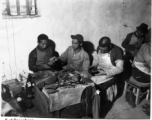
[123,77,150,105]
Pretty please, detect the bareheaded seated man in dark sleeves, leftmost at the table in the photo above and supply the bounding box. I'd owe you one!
[28,34,54,72]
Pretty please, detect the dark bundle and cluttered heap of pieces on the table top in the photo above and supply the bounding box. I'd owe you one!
[33,70,84,94]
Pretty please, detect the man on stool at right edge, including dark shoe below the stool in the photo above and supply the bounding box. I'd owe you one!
[126,42,151,107]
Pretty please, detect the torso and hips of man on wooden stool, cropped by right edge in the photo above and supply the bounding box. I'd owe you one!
[132,42,151,83]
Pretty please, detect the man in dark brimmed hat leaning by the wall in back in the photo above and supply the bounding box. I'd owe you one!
[121,23,148,77]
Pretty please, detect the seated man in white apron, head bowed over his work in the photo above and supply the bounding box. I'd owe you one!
[89,37,123,101]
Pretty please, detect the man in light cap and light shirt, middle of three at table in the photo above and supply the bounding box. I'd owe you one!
[59,34,90,77]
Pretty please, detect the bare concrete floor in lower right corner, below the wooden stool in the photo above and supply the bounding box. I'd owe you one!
[105,97,150,119]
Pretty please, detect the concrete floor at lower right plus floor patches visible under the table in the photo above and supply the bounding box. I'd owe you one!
[24,96,150,119]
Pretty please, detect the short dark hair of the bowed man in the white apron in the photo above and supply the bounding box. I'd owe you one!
[99,36,111,47]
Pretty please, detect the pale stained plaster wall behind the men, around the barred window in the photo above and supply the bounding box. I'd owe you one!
[0,0,151,80]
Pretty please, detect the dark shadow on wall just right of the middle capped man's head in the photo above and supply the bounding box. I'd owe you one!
[83,41,95,65]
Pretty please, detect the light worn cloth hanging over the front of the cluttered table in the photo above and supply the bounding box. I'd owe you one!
[42,83,94,112]
